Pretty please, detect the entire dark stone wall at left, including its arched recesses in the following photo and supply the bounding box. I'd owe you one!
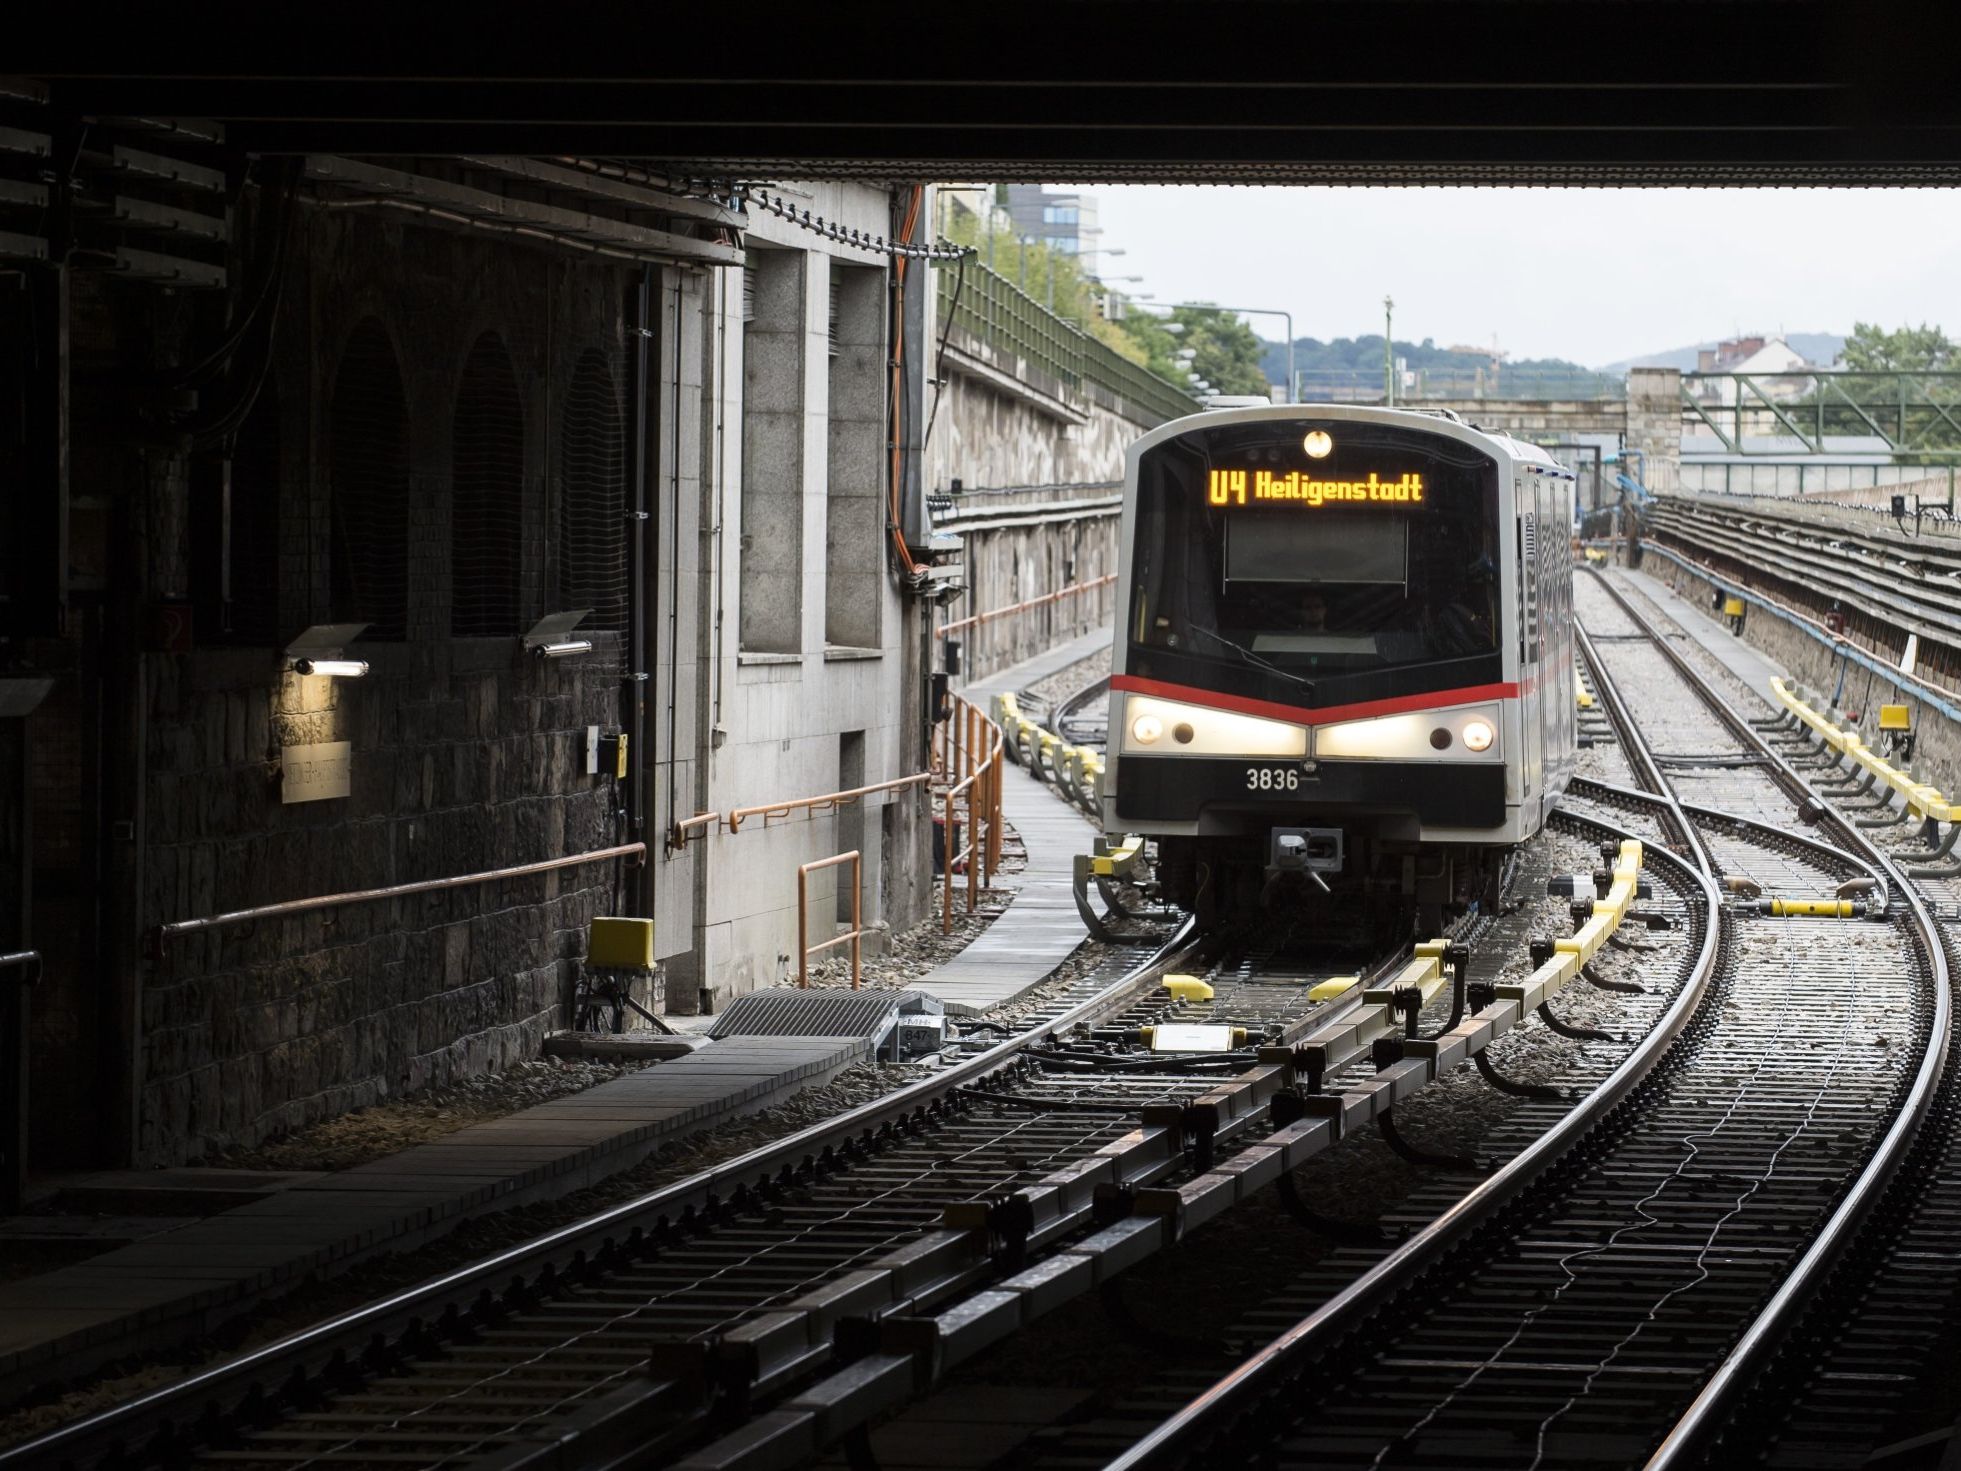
[31,202,637,1167]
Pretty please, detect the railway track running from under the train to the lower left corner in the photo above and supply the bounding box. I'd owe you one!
[11,894,1458,1467]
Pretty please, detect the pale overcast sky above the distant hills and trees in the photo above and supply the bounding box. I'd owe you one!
[1082,184,1961,367]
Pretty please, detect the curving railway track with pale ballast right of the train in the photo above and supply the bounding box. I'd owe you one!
[1116,579,1949,1469]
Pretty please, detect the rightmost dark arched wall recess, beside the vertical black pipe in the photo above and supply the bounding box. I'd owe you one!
[555,349,628,659]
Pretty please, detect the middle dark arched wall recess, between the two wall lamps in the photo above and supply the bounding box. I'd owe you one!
[449,331,524,639]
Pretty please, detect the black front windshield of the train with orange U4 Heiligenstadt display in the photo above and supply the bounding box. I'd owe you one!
[1130,420,1500,706]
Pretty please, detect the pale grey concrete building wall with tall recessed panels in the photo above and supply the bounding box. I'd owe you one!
[655,184,931,1010]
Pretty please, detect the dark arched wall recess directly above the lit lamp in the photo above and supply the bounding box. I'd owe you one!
[327,318,408,639]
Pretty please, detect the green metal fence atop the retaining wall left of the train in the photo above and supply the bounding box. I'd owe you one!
[935,261,1198,420]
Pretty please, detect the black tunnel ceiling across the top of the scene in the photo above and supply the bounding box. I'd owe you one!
[16,0,1961,187]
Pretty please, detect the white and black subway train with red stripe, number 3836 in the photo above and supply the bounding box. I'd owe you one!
[1102,404,1577,943]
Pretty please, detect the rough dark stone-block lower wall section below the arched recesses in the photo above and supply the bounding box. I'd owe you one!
[139,635,618,1161]
